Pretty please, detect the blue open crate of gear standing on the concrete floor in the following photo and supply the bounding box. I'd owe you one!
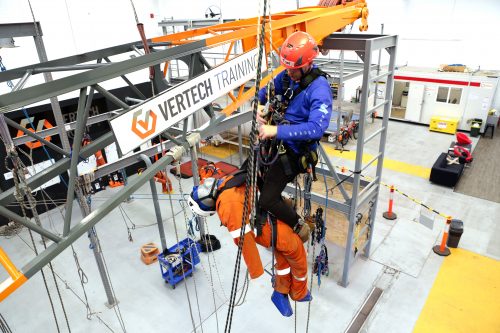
[158,237,201,289]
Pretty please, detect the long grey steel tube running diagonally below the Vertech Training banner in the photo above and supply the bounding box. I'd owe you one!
[21,135,199,279]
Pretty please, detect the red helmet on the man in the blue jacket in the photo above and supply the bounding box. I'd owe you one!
[280,31,319,69]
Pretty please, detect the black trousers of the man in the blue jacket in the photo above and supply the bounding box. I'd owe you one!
[259,154,300,229]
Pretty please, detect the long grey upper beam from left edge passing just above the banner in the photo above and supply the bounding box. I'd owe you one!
[0,40,207,112]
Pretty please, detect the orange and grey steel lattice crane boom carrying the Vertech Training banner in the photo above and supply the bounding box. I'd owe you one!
[0,0,368,301]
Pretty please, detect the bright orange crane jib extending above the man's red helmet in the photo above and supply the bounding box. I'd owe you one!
[150,0,368,115]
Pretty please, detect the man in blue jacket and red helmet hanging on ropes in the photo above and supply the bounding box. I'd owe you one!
[257,31,333,234]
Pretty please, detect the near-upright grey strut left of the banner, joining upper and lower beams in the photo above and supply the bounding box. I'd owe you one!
[63,88,93,236]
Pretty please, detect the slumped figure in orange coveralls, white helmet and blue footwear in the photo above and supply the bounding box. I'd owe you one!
[189,165,312,316]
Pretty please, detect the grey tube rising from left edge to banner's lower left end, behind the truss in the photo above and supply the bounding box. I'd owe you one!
[0,133,114,205]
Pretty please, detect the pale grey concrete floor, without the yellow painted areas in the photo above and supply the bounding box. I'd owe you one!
[0,120,500,333]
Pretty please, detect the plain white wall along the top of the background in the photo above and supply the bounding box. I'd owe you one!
[0,0,500,108]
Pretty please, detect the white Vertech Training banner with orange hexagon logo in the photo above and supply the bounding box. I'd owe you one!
[110,49,265,154]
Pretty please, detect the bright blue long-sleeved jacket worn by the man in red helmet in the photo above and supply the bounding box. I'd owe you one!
[259,66,333,153]
